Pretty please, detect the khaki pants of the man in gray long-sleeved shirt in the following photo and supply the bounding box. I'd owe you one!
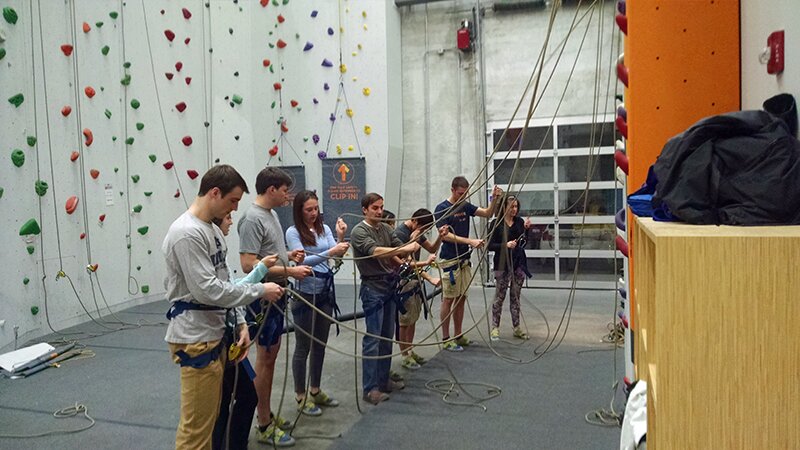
[169,341,227,450]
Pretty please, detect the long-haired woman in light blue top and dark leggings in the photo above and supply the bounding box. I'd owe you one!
[286,191,350,416]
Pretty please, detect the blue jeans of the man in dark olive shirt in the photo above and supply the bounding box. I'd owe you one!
[361,284,397,394]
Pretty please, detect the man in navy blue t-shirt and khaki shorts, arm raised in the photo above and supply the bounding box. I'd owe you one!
[434,176,503,352]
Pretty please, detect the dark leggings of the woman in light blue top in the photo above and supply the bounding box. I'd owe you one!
[292,293,333,394]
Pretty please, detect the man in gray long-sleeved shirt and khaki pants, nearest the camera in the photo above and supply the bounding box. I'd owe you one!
[161,165,283,449]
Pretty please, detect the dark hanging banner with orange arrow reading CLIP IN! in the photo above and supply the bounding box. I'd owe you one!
[319,158,367,236]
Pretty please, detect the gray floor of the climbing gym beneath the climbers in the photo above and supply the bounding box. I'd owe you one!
[0,286,623,449]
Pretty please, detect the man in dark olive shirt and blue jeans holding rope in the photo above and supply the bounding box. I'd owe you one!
[350,192,420,405]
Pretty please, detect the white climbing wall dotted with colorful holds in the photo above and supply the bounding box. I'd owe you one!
[0,0,402,349]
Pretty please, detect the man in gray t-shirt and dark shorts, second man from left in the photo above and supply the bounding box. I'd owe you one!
[238,167,312,447]
